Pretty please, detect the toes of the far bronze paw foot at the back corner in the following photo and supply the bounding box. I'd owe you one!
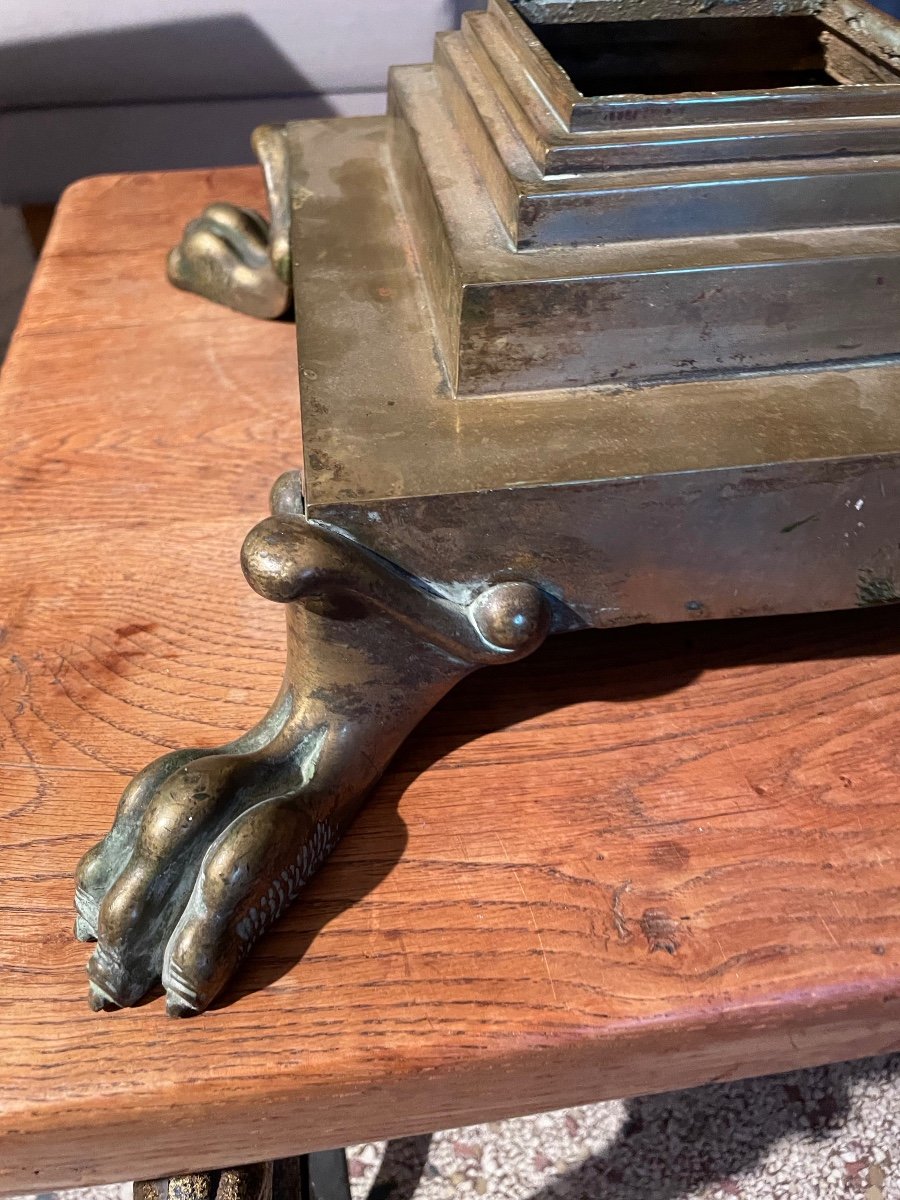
[168,203,290,319]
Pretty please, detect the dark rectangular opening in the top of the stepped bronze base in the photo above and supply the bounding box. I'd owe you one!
[530,17,838,96]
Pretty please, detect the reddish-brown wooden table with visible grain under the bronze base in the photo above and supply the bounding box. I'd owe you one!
[0,169,900,1193]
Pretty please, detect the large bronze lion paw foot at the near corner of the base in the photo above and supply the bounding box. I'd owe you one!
[76,475,550,1015]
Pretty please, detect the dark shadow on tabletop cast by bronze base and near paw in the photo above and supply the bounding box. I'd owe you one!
[216,605,900,1007]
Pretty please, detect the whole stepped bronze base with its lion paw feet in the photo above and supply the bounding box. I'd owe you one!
[77,0,900,1013]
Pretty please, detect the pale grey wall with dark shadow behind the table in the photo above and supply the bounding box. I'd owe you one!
[0,0,481,204]
